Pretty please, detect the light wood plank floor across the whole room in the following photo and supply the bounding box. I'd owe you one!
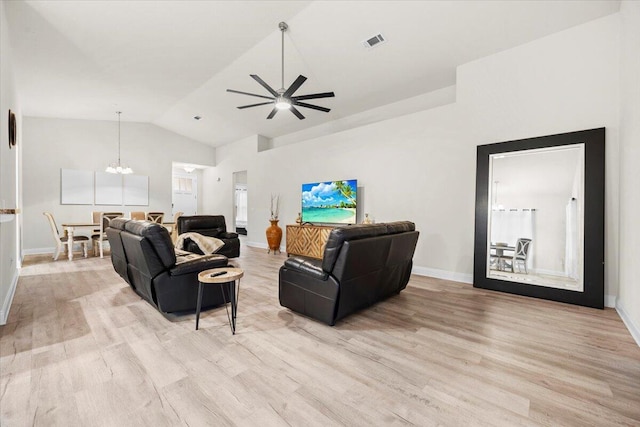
[0,246,640,427]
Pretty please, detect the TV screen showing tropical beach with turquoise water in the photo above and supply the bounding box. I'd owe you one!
[302,179,358,224]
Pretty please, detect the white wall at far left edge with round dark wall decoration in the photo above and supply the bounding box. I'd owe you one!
[0,2,22,325]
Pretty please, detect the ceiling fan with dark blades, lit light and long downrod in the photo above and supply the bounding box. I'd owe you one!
[227,22,335,120]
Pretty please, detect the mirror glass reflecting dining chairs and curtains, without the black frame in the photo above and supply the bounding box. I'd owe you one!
[486,144,585,292]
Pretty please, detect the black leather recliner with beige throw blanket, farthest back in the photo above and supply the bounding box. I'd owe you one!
[178,215,240,258]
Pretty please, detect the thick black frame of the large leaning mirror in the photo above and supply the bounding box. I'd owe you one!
[473,128,605,308]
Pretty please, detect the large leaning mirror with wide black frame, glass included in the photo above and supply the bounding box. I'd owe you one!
[473,128,605,308]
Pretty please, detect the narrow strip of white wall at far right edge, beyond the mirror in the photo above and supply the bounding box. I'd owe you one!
[617,1,640,344]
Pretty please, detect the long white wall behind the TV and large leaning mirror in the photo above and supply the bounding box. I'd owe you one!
[204,14,619,302]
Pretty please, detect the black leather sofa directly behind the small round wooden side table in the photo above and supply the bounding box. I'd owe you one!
[106,218,229,313]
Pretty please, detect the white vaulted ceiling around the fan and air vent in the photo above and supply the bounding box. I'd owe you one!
[3,0,620,146]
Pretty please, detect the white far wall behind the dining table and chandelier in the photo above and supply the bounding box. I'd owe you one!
[23,118,215,253]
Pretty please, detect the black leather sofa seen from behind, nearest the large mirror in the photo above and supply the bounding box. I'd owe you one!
[279,221,419,325]
